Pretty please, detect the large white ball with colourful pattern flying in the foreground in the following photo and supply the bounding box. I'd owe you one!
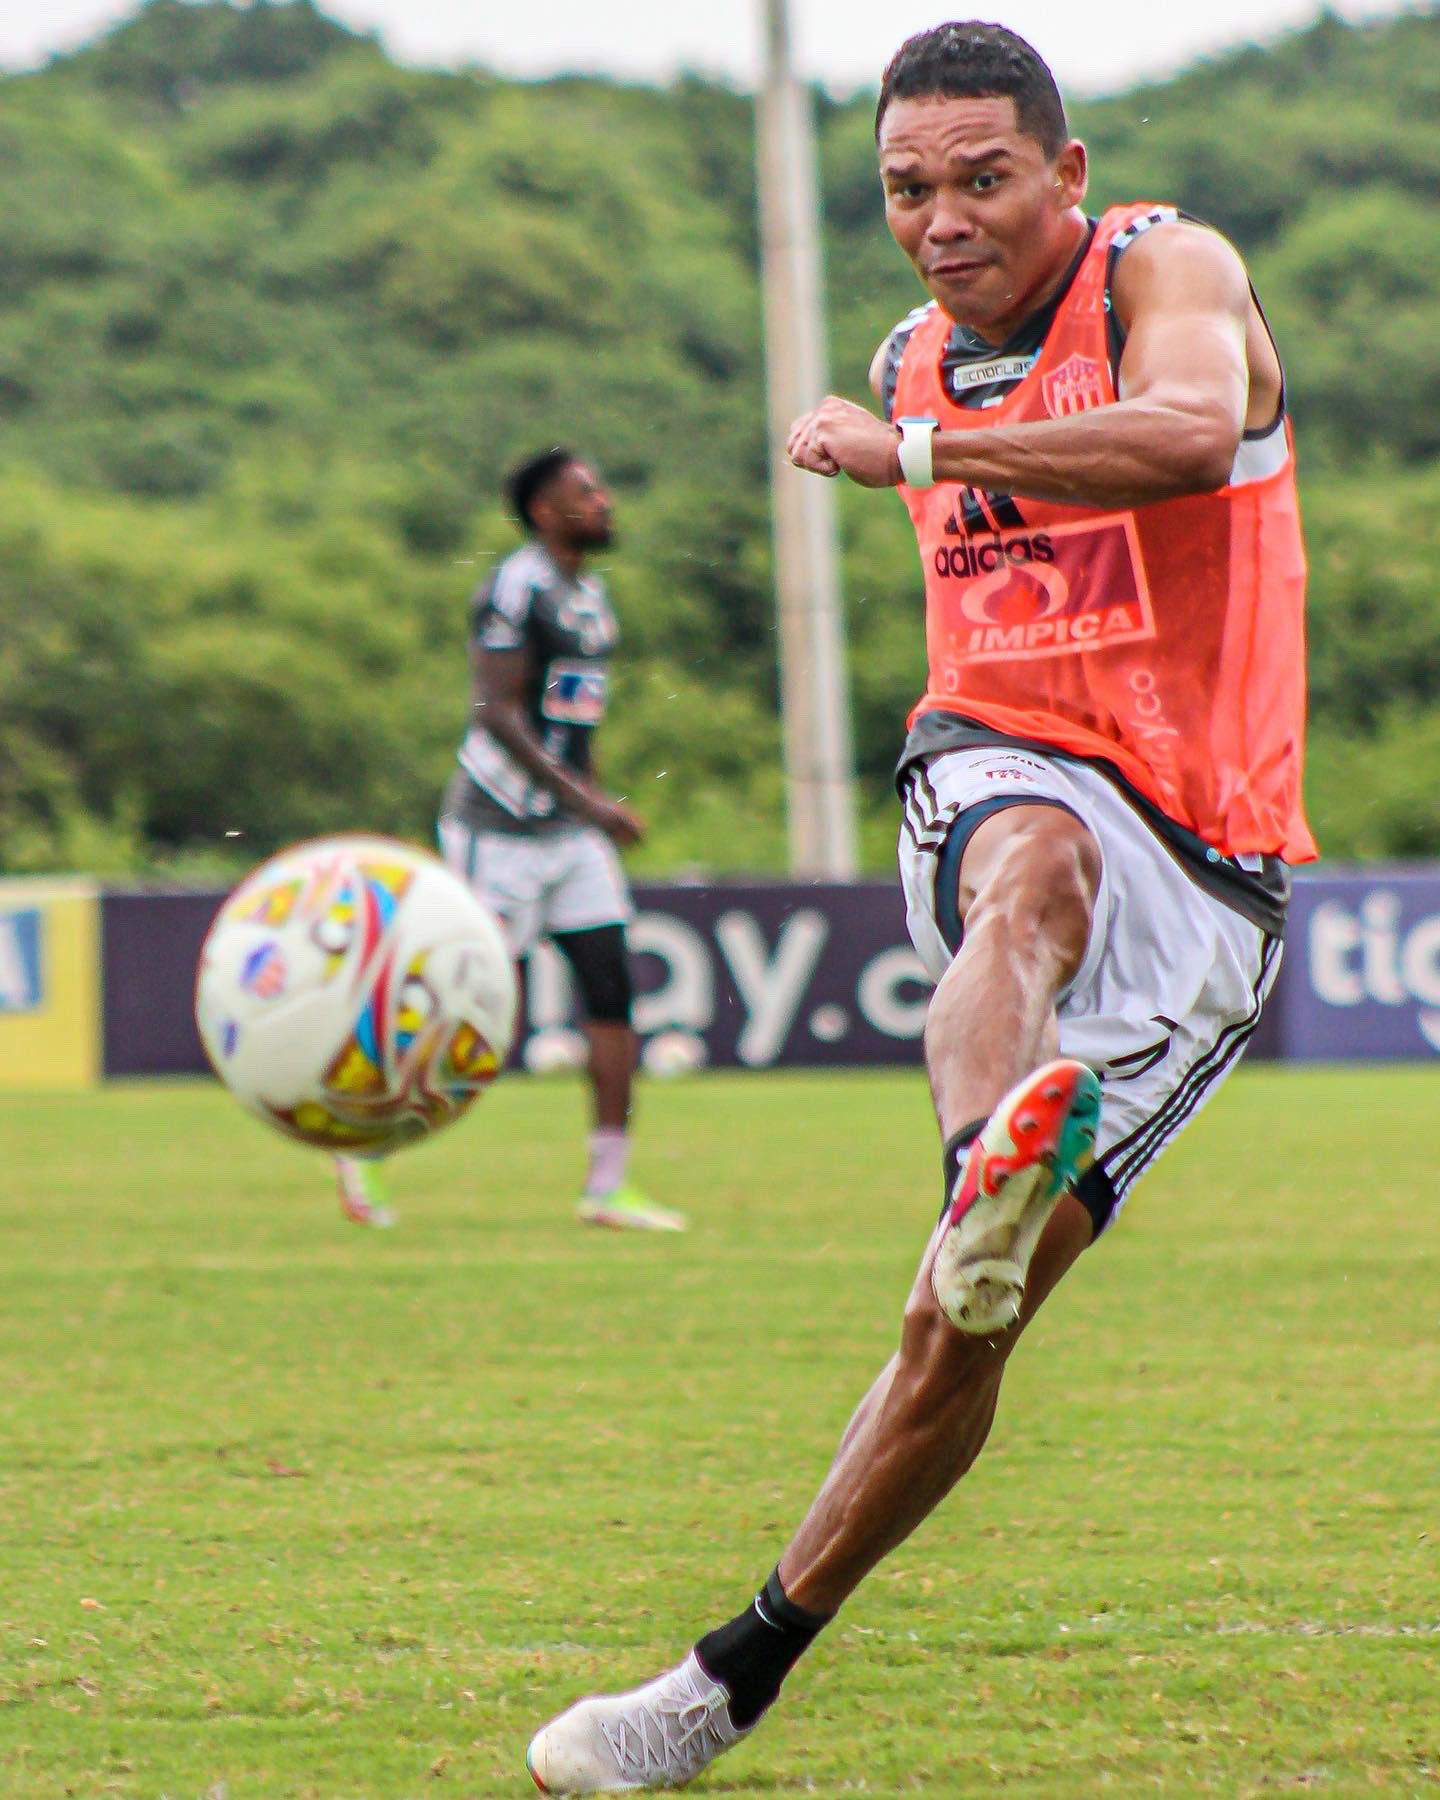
[194,837,515,1156]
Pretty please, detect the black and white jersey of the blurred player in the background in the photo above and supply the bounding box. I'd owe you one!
[443,544,619,835]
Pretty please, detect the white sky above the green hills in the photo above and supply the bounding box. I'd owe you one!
[0,0,1404,94]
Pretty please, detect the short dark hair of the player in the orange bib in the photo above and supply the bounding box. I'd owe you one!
[875,18,1069,157]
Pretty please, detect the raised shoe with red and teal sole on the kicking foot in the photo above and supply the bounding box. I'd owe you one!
[931,1058,1100,1337]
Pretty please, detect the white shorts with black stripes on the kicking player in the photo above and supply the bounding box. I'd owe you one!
[900,749,1280,1238]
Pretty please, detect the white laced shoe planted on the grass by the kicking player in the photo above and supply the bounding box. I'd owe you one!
[526,1651,754,1795]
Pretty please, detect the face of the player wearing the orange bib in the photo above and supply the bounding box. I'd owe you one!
[880,95,1085,344]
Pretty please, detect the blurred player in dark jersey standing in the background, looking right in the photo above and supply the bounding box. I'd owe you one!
[338,448,686,1231]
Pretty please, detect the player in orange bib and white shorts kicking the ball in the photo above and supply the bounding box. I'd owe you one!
[527,23,1316,1795]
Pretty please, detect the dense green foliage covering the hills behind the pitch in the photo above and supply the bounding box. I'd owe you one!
[0,0,1440,873]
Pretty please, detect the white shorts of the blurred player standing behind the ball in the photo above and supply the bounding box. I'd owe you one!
[437,817,635,961]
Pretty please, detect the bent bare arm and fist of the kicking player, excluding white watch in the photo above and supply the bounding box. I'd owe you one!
[790,221,1249,506]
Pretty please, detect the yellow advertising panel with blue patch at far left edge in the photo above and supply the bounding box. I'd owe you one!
[0,880,101,1091]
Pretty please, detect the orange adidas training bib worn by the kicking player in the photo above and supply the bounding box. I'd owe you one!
[893,203,1316,862]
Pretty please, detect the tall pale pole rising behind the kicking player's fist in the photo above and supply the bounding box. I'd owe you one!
[758,0,857,880]
